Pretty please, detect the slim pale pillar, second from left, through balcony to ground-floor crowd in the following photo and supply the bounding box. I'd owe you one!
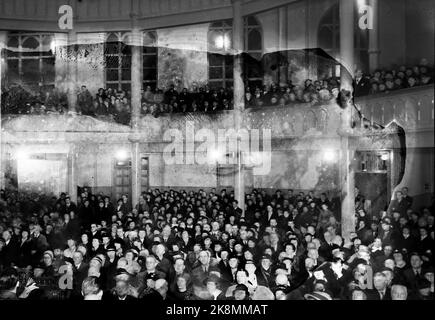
[130,27,142,208]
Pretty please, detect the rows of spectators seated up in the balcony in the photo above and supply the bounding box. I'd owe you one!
[2,59,433,124]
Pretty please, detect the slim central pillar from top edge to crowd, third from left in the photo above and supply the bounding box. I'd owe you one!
[233,0,245,214]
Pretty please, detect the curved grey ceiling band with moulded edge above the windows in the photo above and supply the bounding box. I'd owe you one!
[0,0,296,32]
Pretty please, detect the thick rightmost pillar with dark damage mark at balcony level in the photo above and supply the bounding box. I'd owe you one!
[339,0,355,241]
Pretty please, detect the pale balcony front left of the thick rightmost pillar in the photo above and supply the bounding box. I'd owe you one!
[2,103,340,142]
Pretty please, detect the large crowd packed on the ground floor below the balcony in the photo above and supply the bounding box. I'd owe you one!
[0,188,434,302]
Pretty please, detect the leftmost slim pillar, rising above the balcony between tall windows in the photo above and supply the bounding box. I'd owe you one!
[67,30,79,112]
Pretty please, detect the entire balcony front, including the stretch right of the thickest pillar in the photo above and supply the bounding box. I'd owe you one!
[2,85,434,145]
